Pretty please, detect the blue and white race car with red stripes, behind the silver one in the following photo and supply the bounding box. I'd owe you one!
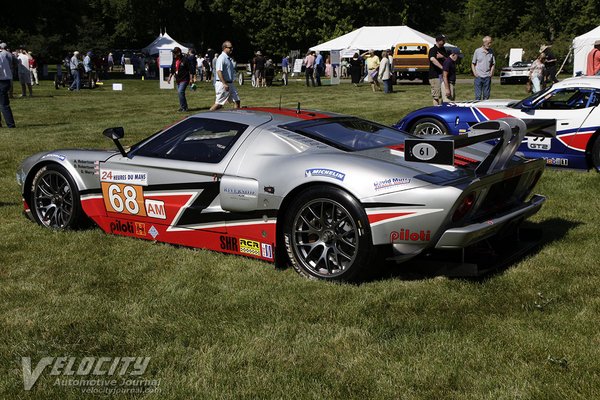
[394,77,600,171]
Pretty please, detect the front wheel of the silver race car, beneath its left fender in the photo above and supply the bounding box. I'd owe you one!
[28,164,85,230]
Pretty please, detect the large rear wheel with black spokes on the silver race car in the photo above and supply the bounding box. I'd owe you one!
[284,186,375,282]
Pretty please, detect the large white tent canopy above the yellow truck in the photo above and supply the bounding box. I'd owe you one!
[310,25,446,51]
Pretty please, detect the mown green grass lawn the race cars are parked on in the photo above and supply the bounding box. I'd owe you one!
[0,76,600,400]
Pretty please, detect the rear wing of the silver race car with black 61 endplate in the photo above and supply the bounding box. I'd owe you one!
[404,118,556,174]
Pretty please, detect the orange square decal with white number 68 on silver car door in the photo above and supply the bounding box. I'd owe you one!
[102,182,146,217]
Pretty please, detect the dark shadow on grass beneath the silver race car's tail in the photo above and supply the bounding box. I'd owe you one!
[374,218,582,281]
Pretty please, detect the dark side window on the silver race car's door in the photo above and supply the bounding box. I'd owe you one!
[135,118,248,163]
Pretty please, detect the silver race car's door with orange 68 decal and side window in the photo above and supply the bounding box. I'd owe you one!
[99,118,250,238]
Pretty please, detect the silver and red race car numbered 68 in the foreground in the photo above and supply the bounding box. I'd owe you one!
[17,108,545,281]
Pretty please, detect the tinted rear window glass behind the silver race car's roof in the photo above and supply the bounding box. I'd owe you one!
[284,118,413,151]
